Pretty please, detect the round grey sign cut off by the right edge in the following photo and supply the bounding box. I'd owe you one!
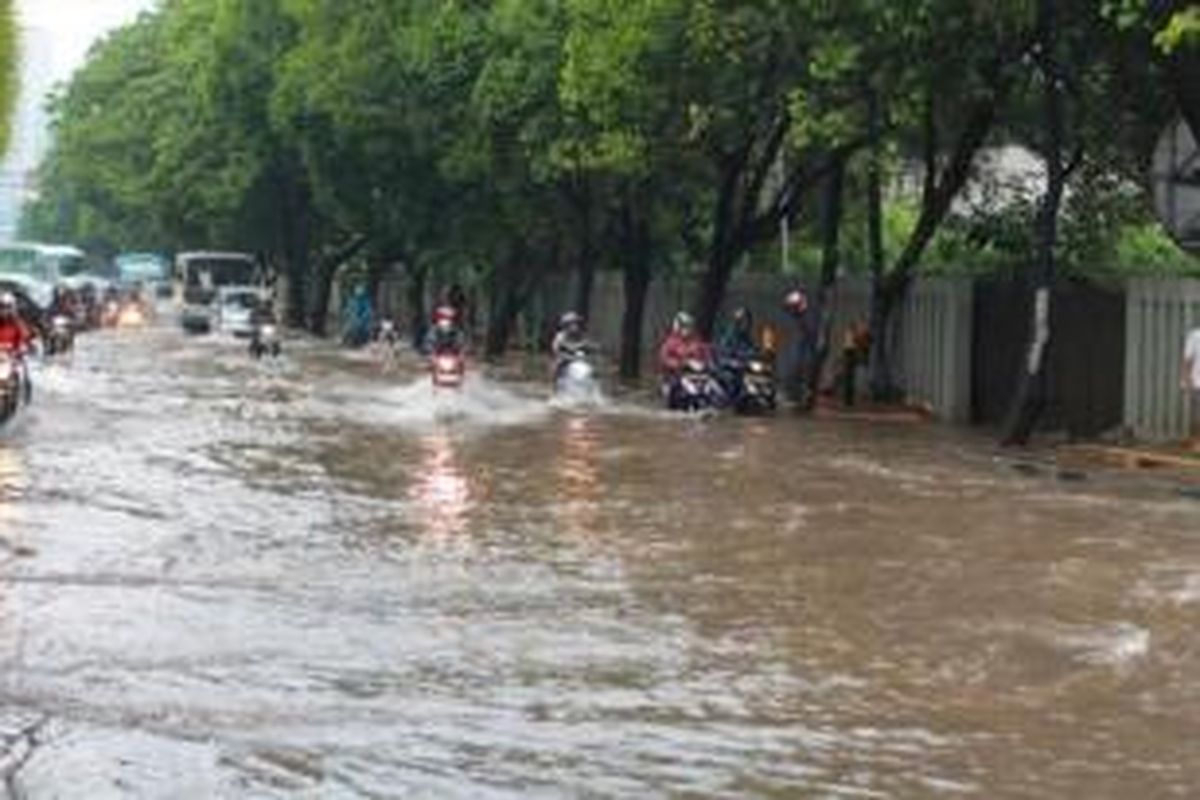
[1151,119,1200,253]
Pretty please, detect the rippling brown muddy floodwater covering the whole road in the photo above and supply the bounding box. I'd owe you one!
[0,330,1200,799]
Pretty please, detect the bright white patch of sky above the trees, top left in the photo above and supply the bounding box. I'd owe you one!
[17,0,154,80]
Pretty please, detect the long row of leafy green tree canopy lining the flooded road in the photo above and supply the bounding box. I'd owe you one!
[18,0,1200,371]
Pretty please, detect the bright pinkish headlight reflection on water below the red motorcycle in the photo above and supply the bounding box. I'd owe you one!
[410,428,474,541]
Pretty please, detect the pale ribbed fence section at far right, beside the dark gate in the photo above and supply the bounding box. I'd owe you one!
[1124,279,1200,441]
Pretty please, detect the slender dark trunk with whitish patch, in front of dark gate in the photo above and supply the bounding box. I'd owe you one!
[1003,0,1067,445]
